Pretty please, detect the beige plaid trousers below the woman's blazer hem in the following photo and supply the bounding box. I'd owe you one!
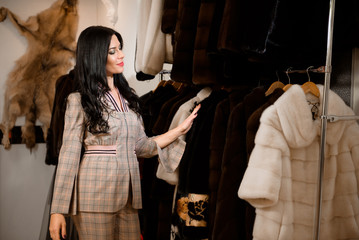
[71,204,141,240]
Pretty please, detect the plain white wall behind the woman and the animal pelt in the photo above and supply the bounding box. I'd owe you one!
[0,0,158,240]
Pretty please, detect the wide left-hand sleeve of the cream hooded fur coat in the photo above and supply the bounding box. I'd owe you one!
[238,109,289,208]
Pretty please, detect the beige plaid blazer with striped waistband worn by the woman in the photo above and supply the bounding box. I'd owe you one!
[51,93,185,215]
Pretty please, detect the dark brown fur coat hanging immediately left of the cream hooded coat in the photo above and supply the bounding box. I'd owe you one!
[211,87,266,240]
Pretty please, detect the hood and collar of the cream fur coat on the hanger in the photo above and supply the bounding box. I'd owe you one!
[261,84,354,148]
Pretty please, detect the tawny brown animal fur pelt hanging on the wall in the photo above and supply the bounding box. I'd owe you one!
[0,0,78,149]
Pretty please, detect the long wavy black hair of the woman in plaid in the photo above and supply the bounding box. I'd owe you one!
[74,26,140,134]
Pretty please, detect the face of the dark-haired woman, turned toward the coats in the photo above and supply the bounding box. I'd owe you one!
[106,35,125,76]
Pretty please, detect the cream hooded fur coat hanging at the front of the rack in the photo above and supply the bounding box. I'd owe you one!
[238,85,359,240]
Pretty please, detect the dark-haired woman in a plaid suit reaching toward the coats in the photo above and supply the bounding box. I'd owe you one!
[49,26,199,240]
